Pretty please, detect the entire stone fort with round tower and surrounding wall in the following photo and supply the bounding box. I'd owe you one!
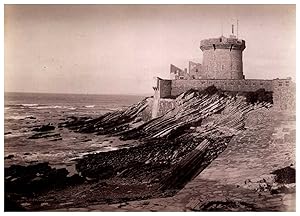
[152,30,296,118]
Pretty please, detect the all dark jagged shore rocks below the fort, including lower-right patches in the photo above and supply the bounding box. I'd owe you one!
[5,87,295,211]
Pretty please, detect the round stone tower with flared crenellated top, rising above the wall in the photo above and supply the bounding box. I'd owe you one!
[200,36,246,79]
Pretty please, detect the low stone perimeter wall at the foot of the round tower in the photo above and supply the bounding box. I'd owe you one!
[152,78,296,118]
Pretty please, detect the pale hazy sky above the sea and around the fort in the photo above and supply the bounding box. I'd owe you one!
[4,5,296,94]
